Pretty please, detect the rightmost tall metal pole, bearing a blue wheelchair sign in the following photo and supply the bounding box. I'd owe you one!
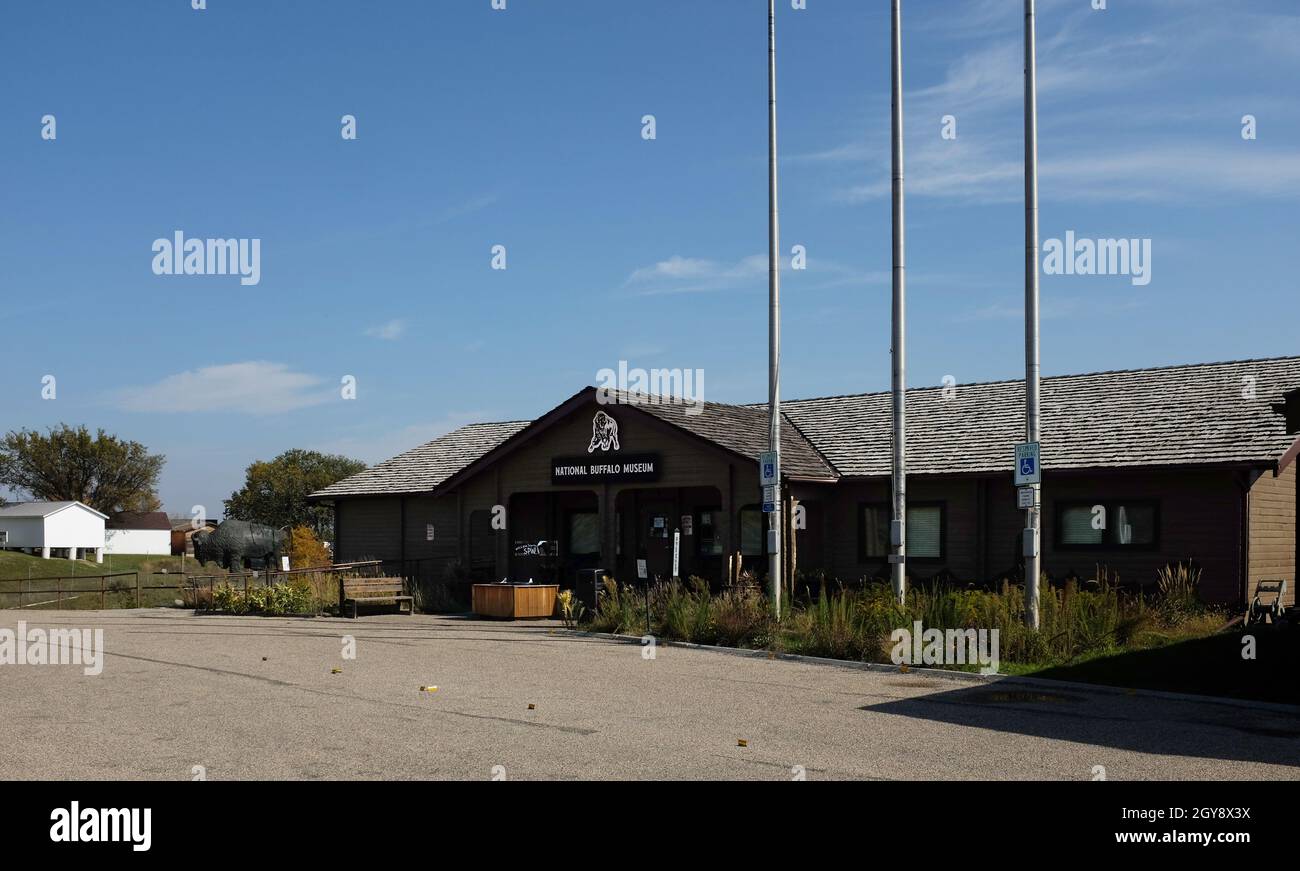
[1024,0,1043,629]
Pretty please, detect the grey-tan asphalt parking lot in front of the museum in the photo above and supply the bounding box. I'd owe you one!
[0,608,1300,780]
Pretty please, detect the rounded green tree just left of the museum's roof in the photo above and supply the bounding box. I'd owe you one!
[225,449,365,541]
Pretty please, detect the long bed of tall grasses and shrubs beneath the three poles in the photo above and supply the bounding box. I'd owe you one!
[590,567,1222,664]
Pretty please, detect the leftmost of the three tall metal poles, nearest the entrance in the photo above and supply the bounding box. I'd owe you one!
[767,0,781,619]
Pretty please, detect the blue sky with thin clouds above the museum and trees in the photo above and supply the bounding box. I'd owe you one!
[0,0,1300,515]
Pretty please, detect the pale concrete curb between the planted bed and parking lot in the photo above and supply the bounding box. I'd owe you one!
[564,629,1300,716]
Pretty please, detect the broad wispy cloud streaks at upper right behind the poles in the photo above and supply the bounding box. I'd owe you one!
[792,0,1300,204]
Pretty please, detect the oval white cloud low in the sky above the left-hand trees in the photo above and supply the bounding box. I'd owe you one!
[112,360,337,415]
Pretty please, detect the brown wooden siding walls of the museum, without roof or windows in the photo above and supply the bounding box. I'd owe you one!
[337,413,1296,603]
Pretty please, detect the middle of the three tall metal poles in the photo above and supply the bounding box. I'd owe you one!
[889,0,907,605]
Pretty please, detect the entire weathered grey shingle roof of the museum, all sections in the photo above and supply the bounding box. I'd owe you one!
[312,358,1300,498]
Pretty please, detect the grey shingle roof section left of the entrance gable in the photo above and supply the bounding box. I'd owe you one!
[311,420,530,499]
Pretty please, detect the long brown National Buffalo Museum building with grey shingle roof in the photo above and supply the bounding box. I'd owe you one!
[312,358,1300,603]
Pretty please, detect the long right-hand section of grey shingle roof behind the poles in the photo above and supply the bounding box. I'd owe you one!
[781,358,1300,476]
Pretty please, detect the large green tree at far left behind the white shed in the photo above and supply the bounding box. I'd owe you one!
[0,424,166,515]
